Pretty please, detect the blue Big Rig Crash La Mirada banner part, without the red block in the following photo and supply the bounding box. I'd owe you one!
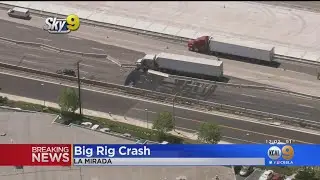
[73,144,320,166]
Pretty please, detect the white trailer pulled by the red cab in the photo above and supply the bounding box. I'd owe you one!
[209,37,274,62]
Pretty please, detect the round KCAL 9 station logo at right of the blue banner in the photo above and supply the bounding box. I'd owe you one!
[268,145,294,165]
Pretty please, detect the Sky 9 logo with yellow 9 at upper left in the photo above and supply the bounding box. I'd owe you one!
[43,14,80,34]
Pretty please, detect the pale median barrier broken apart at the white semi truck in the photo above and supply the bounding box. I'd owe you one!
[0,37,320,99]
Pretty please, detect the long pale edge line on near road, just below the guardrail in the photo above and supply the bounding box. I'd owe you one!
[0,72,320,136]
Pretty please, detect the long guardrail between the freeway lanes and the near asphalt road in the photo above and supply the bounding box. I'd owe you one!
[0,60,320,129]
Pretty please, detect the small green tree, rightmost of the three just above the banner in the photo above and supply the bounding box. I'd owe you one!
[198,123,221,144]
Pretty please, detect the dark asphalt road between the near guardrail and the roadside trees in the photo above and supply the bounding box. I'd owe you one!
[0,72,320,143]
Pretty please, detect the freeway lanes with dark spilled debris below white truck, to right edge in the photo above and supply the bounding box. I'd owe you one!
[136,72,320,121]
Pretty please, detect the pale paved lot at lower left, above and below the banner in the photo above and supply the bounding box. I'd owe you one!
[0,110,233,180]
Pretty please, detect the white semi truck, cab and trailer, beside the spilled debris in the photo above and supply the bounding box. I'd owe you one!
[136,53,223,79]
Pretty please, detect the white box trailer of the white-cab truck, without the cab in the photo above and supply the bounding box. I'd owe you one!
[154,53,223,77]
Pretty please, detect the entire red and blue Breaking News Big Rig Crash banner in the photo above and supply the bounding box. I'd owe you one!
[0,144,320,166]
